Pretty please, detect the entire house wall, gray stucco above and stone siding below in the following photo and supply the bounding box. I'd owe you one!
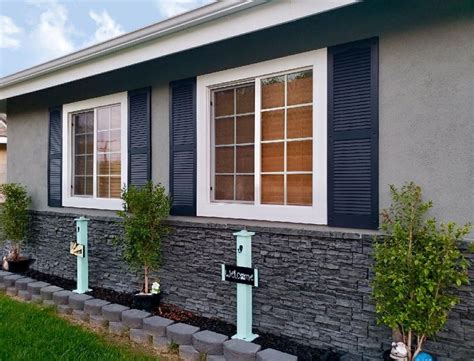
[3,1,474,360]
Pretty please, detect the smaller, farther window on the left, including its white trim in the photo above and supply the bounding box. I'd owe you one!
[63,93,127,209]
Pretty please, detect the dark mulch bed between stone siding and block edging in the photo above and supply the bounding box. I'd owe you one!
[25,270,341,361]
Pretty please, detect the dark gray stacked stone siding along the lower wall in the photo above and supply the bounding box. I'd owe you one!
[9,212,474,361]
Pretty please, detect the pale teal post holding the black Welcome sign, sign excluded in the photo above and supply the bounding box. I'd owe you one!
[232,230,258,342]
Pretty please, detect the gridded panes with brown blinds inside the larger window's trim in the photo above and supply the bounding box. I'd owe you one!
[211,70,313,206]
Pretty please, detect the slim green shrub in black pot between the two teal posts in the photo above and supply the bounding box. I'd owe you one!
[117,182,171,310]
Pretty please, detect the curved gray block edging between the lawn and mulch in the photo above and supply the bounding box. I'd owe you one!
[0,270,297,361]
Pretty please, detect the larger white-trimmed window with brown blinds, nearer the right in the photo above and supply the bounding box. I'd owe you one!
[197,49,327,224]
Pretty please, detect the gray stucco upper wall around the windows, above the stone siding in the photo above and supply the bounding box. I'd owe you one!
[8,9,474,238]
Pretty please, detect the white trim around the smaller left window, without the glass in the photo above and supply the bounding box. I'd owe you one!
[62,92,128,210]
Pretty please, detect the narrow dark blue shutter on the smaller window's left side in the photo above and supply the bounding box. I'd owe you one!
[48,106,63,207]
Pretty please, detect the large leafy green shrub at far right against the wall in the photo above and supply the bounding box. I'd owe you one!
[372,182,470,361]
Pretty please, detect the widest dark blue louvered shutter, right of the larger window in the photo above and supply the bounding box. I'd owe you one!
[328,38,379,229]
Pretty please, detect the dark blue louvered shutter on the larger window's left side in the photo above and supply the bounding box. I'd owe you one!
[170,78,196,216]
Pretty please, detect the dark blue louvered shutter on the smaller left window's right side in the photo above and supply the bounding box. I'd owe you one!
[128,88,151,187]
